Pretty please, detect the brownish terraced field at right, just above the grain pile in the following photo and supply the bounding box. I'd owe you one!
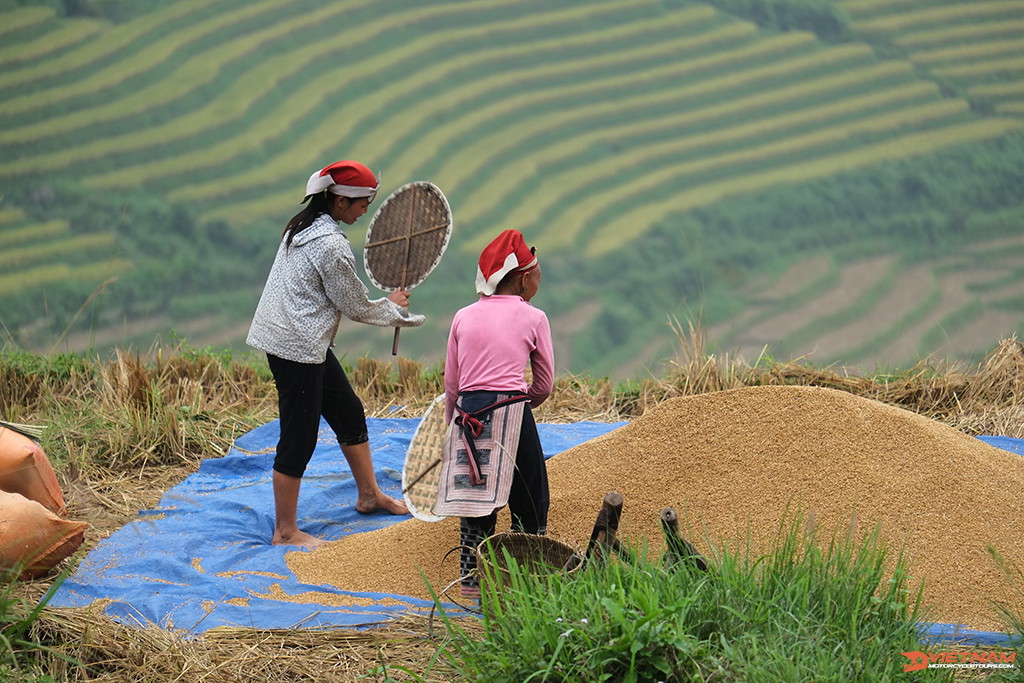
[708,229,1024,369]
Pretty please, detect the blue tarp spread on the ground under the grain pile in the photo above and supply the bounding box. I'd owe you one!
[50,418,1024,644]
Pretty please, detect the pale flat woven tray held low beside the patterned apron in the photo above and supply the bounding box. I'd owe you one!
[401,394,447,522]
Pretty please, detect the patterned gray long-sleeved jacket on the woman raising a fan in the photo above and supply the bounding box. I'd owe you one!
[246,214,424,364]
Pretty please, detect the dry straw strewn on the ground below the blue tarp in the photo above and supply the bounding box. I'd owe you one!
[34,603,479,683]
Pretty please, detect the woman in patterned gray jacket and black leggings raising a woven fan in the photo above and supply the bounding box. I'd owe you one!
[246,161,424,548]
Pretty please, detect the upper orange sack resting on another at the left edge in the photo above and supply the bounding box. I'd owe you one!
[0,427,68,515]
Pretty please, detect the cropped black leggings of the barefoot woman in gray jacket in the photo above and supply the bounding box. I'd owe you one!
[266,349,370,477]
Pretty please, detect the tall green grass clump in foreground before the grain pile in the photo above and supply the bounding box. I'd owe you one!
[425,523,1022,682]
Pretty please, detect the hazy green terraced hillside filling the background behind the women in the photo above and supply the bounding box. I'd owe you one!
[0,0,1024,378]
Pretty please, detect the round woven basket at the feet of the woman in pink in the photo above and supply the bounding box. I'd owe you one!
[476,531,582,590]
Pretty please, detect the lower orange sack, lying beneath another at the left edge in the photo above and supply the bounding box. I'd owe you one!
[0,490,86,579]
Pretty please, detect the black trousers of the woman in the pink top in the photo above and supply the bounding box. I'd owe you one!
[459,391,551,587]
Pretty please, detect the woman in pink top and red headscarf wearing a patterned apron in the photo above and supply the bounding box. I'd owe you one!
[434,230,554,597]
